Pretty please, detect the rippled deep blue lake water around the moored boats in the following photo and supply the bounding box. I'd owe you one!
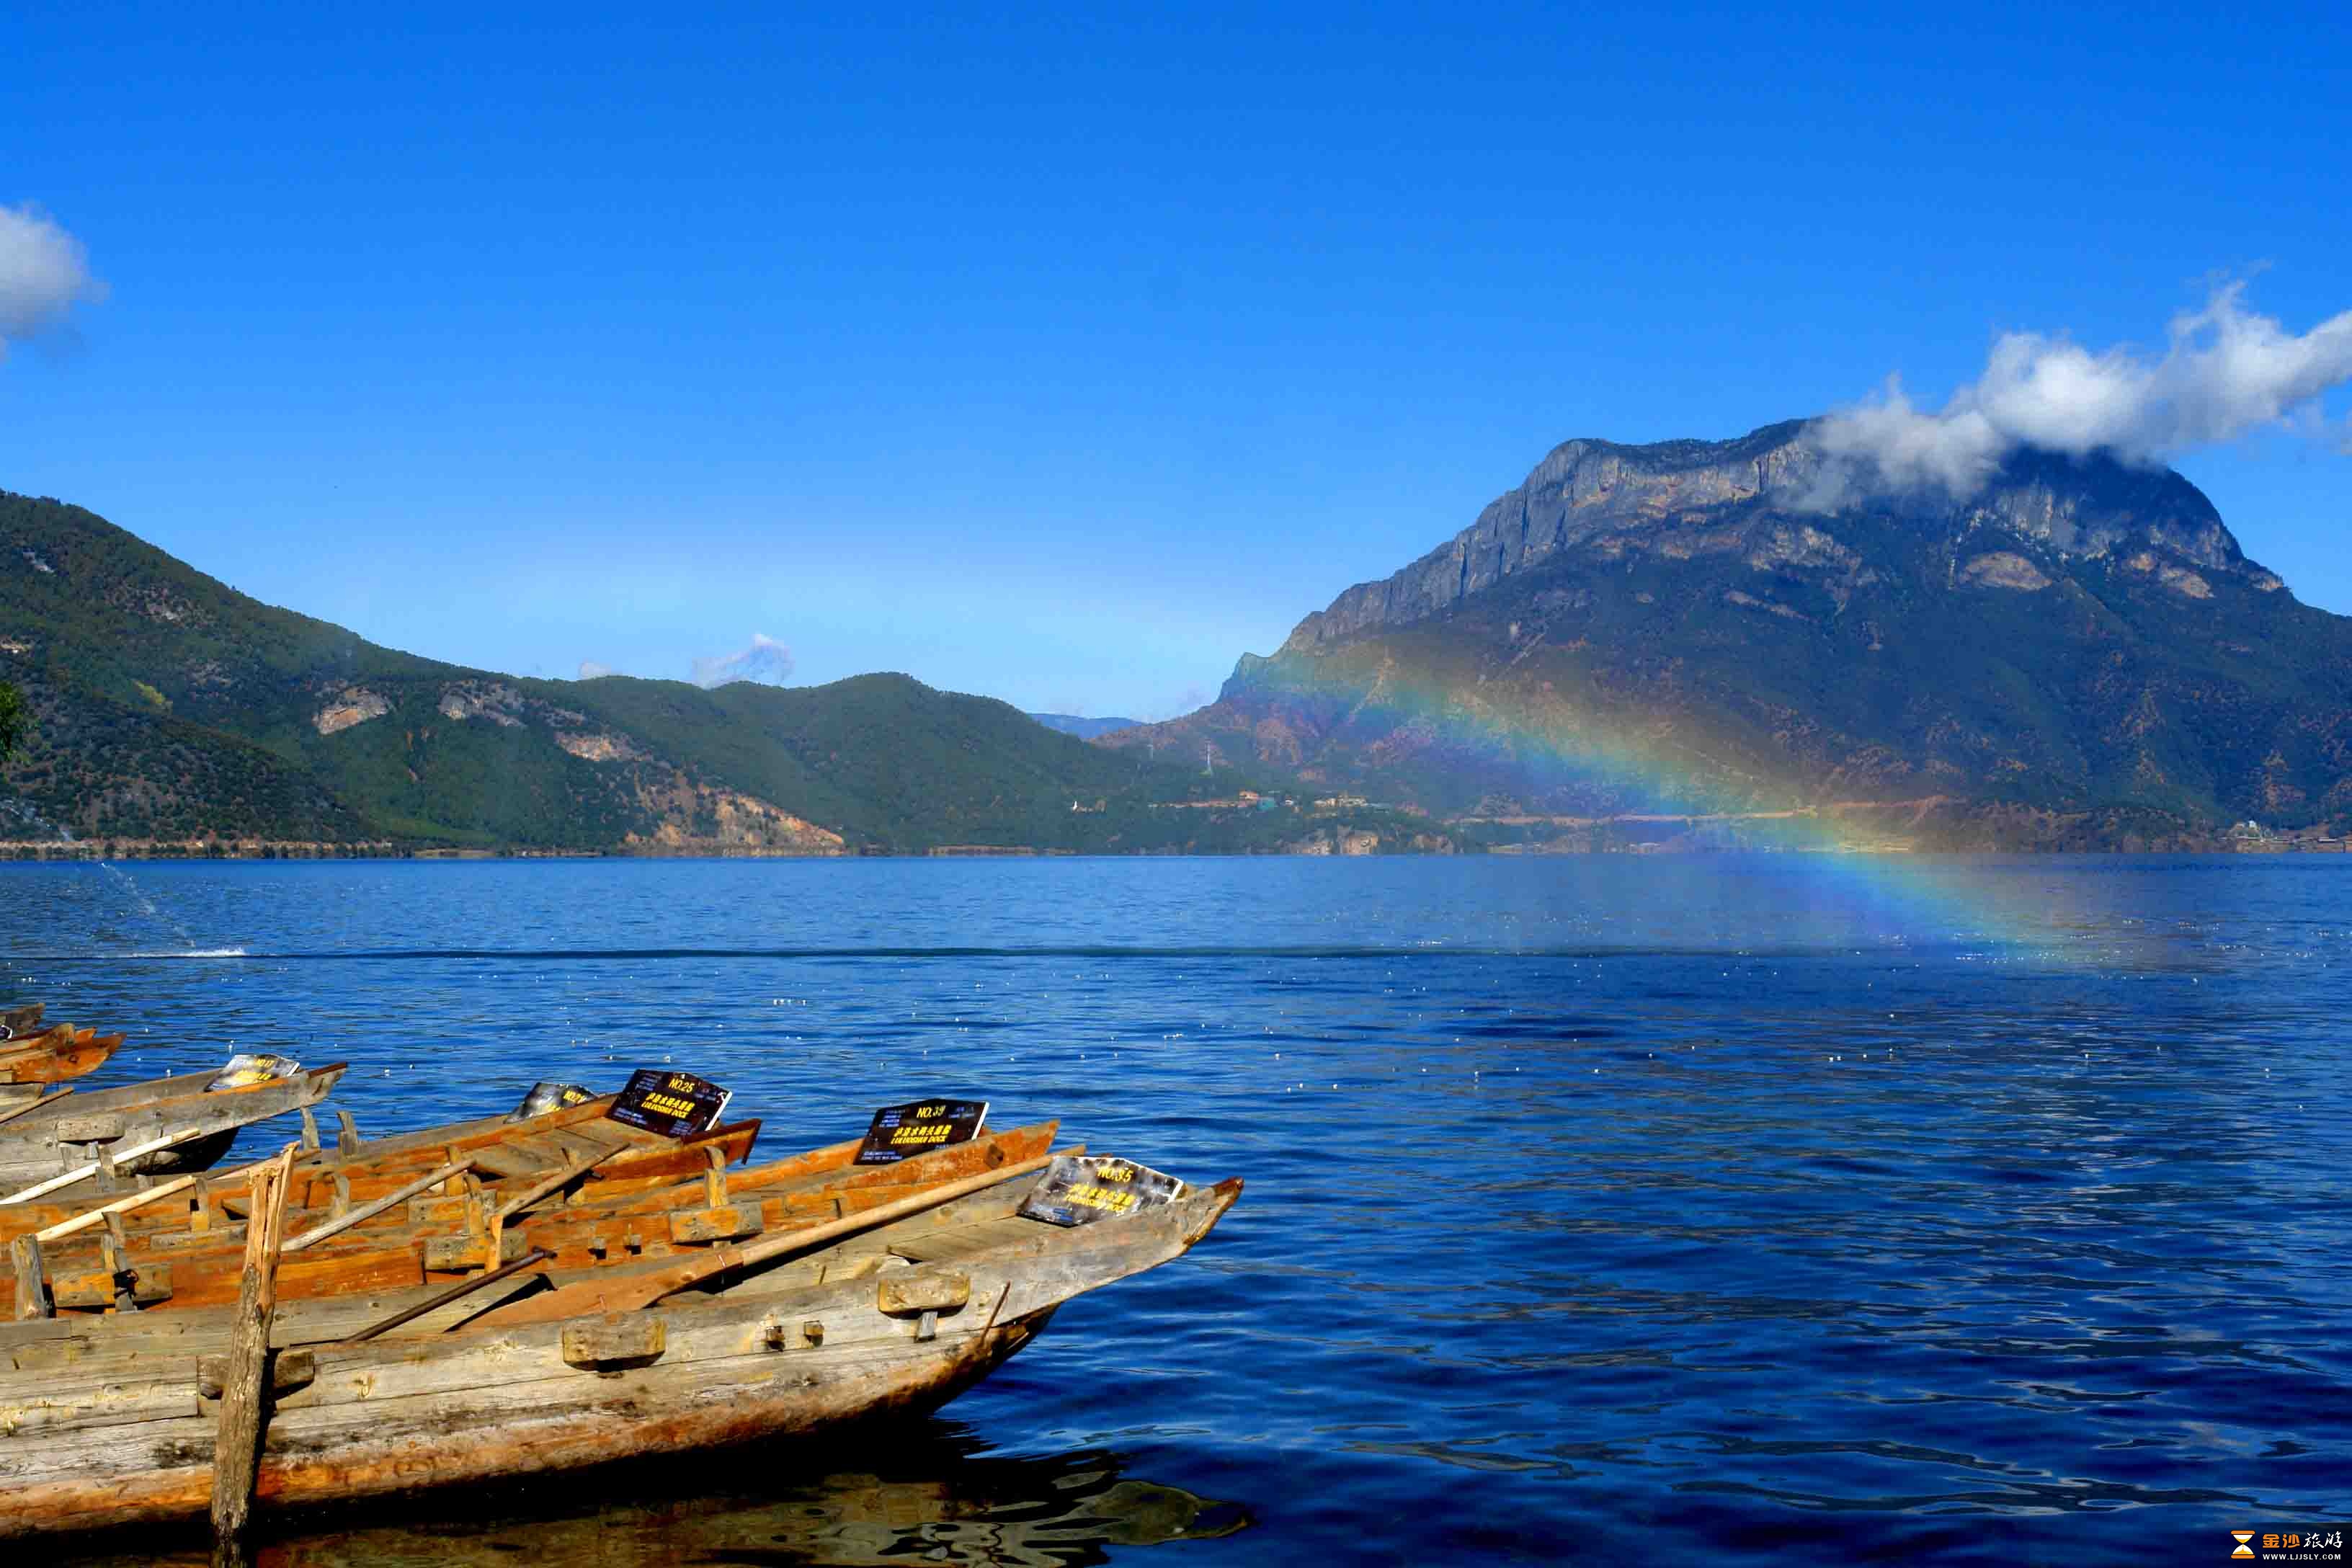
[0,856,2352,1568]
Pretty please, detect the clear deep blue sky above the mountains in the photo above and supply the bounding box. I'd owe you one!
[0,5,2352,717]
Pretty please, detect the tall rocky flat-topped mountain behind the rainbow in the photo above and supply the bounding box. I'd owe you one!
[1110,421,2352,842]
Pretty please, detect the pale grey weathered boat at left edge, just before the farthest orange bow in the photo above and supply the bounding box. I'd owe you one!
[0,1063,346,1194]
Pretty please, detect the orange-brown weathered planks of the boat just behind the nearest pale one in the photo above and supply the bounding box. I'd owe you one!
[0,1121,1056,1311]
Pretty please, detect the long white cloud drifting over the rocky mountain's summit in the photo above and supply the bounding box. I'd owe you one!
[1809,282,2352,505]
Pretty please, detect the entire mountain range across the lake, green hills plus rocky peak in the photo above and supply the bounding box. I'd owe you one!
[22,421,2352,853]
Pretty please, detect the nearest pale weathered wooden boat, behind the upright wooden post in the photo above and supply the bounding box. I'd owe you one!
[0,1164,1242,1535]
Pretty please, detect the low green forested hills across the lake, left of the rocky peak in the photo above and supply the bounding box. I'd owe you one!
[0,491,1307,853]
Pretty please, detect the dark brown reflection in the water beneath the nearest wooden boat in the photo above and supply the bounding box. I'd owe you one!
[64,1417,1251,1568]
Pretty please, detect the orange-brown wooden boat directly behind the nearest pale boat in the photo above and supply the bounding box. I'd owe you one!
[0,1121,1056,1317]
